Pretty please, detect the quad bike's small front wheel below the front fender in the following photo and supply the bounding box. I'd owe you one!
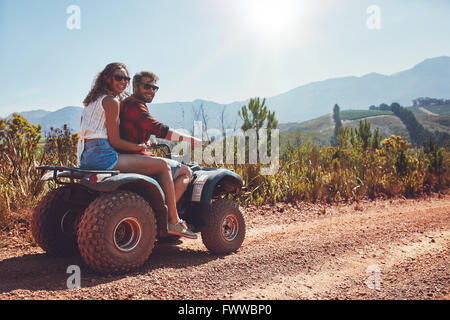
[201,199,245,254]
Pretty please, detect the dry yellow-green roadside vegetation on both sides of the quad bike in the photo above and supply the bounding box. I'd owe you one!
[0,99,450,229]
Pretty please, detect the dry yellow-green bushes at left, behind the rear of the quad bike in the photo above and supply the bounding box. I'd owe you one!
[0,114,78,227]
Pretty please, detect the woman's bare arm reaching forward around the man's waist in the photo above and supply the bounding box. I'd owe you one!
[102,96,146,152]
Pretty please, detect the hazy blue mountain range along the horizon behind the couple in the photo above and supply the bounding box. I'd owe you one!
[4,56,450,131]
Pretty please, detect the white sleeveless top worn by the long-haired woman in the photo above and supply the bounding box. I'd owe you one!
[77,94,108,165]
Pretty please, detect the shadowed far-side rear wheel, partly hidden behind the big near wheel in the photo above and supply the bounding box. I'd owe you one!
[31,187,90,256]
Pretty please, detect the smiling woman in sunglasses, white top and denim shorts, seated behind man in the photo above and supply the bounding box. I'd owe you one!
[78,63,197,239]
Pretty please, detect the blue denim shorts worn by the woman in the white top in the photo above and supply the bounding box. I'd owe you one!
[80,139,119,170]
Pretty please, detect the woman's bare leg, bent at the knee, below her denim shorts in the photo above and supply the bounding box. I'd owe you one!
[114,154,181,224]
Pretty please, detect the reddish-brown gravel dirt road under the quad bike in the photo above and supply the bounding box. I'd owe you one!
[0,194,450,300]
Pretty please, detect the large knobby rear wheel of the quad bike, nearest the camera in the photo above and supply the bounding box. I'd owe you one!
[78,191,157,273]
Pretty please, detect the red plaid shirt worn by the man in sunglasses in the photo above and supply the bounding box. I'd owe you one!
[119,96,169,155]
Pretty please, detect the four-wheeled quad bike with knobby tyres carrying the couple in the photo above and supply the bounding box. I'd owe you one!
[32,144,245,273]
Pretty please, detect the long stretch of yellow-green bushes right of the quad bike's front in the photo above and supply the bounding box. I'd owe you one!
[233,130,450,205]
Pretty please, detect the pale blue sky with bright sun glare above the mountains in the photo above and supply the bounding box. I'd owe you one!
[0,0,450,117]
